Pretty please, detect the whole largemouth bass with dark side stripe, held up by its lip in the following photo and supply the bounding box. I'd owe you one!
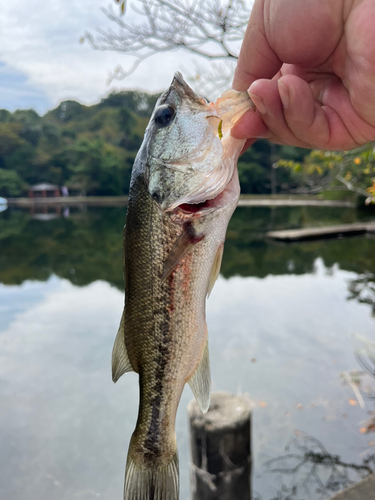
[112,72,252,500]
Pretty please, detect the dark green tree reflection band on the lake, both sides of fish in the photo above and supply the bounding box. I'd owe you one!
[0,207,375,290]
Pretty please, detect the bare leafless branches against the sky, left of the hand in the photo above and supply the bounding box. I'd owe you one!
[81,0,251,93]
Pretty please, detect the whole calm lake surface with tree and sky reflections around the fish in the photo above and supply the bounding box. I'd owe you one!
[0,207,375,500]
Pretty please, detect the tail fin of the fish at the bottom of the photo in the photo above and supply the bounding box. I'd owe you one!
[124,450,179,500]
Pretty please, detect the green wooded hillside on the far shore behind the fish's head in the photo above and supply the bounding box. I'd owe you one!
[0,91,307,197]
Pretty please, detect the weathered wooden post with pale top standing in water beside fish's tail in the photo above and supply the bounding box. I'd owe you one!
[188,392,251,500]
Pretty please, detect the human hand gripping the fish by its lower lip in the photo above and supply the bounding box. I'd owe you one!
[231,0,375,150]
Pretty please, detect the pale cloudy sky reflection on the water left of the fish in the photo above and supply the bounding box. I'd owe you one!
[0,278,128,500]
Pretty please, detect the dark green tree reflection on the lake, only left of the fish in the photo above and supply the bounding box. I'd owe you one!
[0,208,125,290]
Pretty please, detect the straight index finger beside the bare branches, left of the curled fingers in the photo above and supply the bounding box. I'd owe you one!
[232,0,282,91]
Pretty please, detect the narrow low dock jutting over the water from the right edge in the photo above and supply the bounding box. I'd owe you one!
[267,222,375,242]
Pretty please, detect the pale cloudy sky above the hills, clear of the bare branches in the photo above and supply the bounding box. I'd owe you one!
[0,0,250,114]
